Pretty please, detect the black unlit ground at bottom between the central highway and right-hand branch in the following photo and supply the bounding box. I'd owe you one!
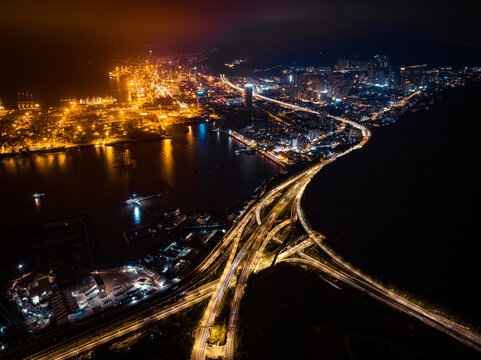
[235,263,478,360]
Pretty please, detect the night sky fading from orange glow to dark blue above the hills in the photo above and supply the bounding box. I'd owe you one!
[0,0,481,55]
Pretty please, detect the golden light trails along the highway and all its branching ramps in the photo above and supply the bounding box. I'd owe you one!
[25,76,481,360]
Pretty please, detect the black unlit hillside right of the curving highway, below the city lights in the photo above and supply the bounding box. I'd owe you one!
[303,84,481,328]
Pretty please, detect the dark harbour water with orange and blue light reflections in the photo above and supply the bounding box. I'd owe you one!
[0,124,279,257]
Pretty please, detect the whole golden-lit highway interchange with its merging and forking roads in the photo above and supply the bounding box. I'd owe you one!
[24,76,481,360]
